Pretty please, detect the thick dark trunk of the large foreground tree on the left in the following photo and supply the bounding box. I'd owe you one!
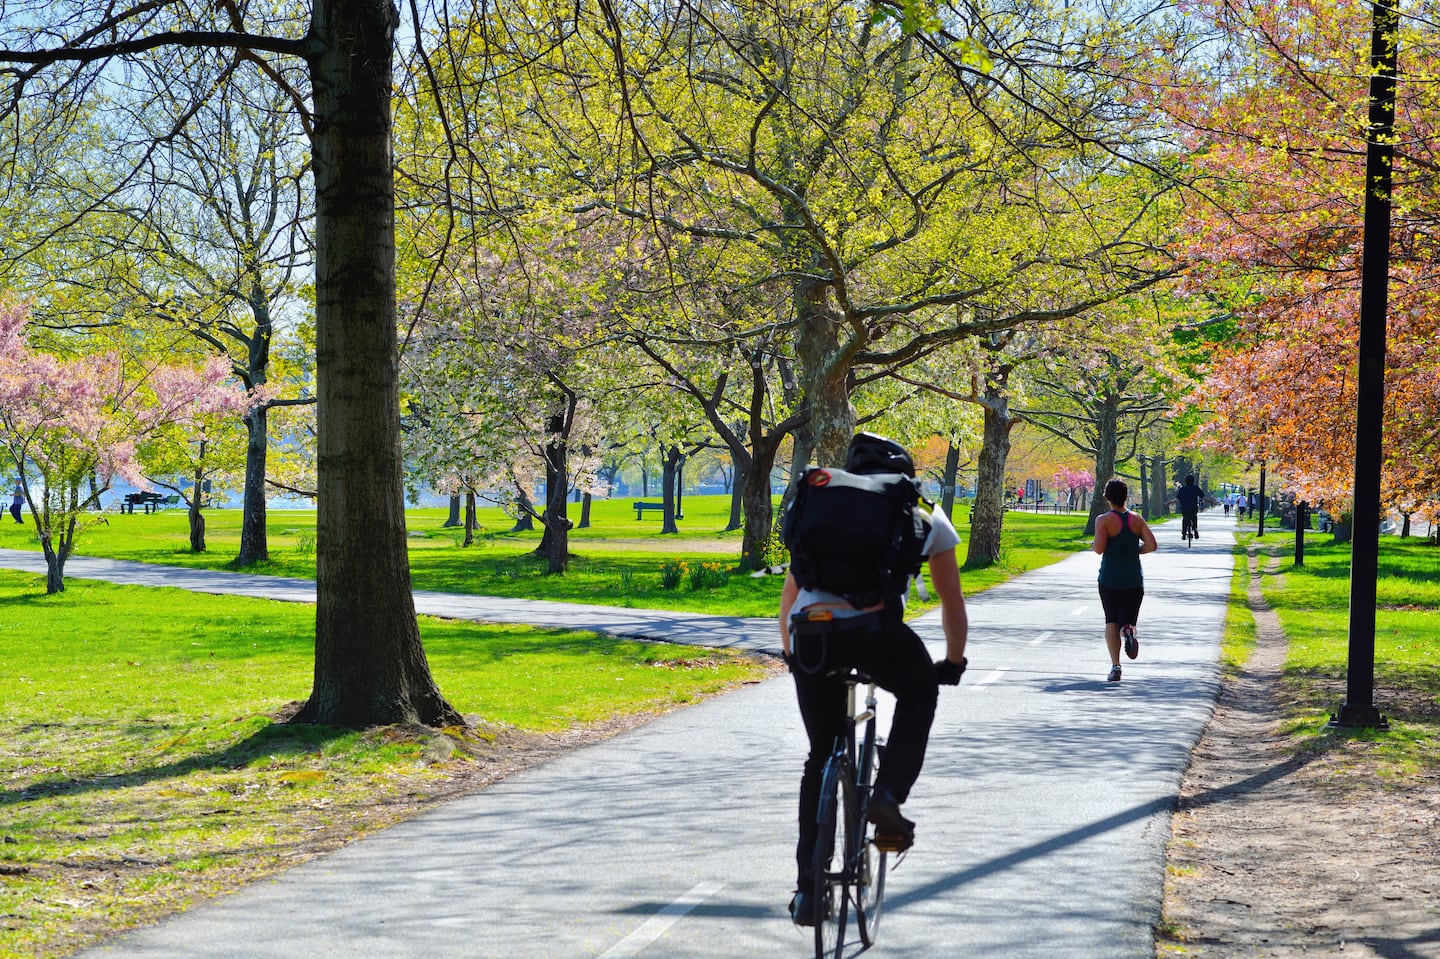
[295,0,464,729]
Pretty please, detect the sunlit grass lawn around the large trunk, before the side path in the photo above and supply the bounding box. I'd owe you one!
[0,572,773,956]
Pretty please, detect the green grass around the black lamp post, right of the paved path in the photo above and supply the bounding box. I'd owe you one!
[1241,531,1440,776]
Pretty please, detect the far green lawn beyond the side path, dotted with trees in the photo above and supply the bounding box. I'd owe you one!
[0,495,1089,616]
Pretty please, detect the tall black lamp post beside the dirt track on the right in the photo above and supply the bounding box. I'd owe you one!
[1331,0,1400,727]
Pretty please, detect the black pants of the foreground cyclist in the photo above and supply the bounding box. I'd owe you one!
[791,623,939,888]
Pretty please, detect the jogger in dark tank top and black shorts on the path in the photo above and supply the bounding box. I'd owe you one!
[1092,480,1158,683]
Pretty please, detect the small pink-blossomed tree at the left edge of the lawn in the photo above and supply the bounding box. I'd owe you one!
[0,304,241,593]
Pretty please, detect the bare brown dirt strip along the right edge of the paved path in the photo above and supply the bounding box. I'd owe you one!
[1156,559,1440,959]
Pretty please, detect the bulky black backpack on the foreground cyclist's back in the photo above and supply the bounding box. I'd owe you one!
[780,467,929,619]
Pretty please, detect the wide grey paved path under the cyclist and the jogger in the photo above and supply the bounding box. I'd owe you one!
[0,524,1231,959]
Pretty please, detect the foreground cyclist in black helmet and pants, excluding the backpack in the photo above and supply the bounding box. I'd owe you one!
[779,433,969,924]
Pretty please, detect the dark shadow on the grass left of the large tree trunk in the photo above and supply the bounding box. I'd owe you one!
[0,723,354,805]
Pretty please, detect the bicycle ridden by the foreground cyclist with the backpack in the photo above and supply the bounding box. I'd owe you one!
[812,670,888,959]
